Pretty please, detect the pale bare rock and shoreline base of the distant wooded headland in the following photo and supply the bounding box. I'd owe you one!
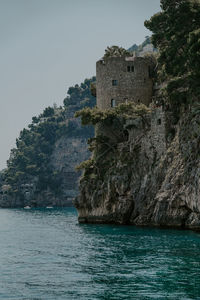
[0,136,89,207]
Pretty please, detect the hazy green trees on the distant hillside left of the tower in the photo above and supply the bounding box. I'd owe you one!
[4,77,96,195]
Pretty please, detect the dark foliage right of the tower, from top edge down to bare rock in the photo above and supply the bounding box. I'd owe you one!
[145,0,200,110]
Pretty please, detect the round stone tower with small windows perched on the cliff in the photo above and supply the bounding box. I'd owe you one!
[96,57,153,109]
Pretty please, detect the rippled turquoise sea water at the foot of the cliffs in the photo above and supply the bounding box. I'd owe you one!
[0,208,200,300]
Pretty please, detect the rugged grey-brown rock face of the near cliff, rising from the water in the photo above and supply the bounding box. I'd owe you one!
[76,105,200,229]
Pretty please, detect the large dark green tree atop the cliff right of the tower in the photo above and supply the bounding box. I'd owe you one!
[145,0,200,88]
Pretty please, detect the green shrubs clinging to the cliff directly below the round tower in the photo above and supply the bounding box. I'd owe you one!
[75,103,151,181]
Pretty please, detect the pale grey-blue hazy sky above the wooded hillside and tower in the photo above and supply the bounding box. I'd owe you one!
[0,0,160,169]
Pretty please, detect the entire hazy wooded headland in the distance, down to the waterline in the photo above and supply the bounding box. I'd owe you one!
[0,77,96,207]
